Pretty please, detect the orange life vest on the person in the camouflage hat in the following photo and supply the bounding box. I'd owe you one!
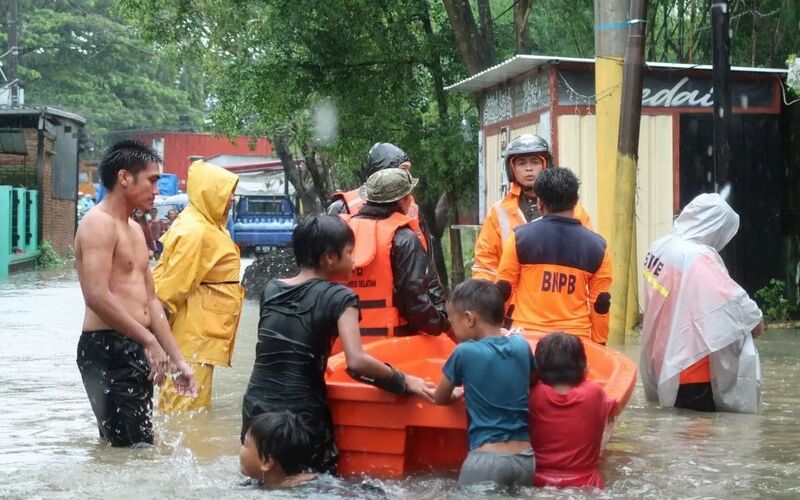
[344,212,427,340]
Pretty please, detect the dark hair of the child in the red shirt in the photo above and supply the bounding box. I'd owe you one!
[533,332,586,386]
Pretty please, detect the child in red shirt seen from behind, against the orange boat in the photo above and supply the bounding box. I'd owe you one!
[529,332,614,488]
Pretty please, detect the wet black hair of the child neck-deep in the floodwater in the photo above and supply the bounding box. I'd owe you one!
[247,410,313,475]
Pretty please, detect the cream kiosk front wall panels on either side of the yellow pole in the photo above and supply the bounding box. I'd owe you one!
[558,115,673,303]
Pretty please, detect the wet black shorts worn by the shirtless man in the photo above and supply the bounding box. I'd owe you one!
[77,330,153,447]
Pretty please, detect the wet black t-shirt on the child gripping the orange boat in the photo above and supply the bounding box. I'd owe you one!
[242,279,358,470]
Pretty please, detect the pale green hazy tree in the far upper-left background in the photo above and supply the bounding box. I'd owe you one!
[0,0,205,150]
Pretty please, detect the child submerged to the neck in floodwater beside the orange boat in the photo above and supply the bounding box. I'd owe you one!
[239,411,316,489]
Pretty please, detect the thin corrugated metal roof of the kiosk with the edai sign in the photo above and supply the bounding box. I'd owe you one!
[445,54,788,92]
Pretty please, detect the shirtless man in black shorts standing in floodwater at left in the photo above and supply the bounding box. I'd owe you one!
[75,141,196,447]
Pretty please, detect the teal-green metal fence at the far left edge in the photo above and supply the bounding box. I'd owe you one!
[0,186,39,279]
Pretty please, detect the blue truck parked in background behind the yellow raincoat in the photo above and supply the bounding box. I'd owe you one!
[233,195,296,253]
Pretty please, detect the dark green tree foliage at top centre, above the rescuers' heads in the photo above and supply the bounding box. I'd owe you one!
[120,0,477,208]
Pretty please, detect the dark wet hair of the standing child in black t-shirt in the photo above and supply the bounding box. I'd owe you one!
[292,215,356,269]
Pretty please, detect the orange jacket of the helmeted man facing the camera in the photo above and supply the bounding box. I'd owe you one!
[472,182,592,281]
